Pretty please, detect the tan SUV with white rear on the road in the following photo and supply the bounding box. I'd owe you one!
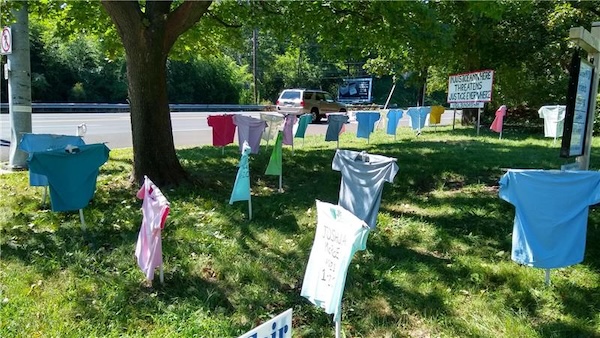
[276,89,348,123]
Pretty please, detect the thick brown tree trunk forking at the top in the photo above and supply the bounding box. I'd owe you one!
[102,1,211,186]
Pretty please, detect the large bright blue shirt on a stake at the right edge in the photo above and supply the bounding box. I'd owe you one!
[499,169,600,269]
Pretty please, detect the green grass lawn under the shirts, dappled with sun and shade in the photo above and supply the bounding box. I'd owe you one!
[0,127,600,338]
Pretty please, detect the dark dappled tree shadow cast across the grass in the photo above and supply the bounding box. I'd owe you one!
[2,130,599,336]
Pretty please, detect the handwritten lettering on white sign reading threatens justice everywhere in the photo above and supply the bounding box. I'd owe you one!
[448,70,494,103]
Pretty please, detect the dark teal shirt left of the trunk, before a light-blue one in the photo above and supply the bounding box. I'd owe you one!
[27,143,110,211]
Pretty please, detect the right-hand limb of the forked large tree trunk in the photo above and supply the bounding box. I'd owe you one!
[164,0,212,51]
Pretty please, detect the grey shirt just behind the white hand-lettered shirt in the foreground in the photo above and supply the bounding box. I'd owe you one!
[331,150,398,229]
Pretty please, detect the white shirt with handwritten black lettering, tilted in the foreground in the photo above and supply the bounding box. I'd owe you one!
[300,200,369,320]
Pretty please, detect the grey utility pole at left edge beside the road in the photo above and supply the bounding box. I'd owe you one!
[7,1,32,170]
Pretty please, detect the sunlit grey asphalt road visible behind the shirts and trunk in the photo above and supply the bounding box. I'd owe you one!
[0,110,460,162]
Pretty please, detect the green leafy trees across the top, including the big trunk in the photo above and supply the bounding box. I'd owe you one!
[2,0,600,184]
